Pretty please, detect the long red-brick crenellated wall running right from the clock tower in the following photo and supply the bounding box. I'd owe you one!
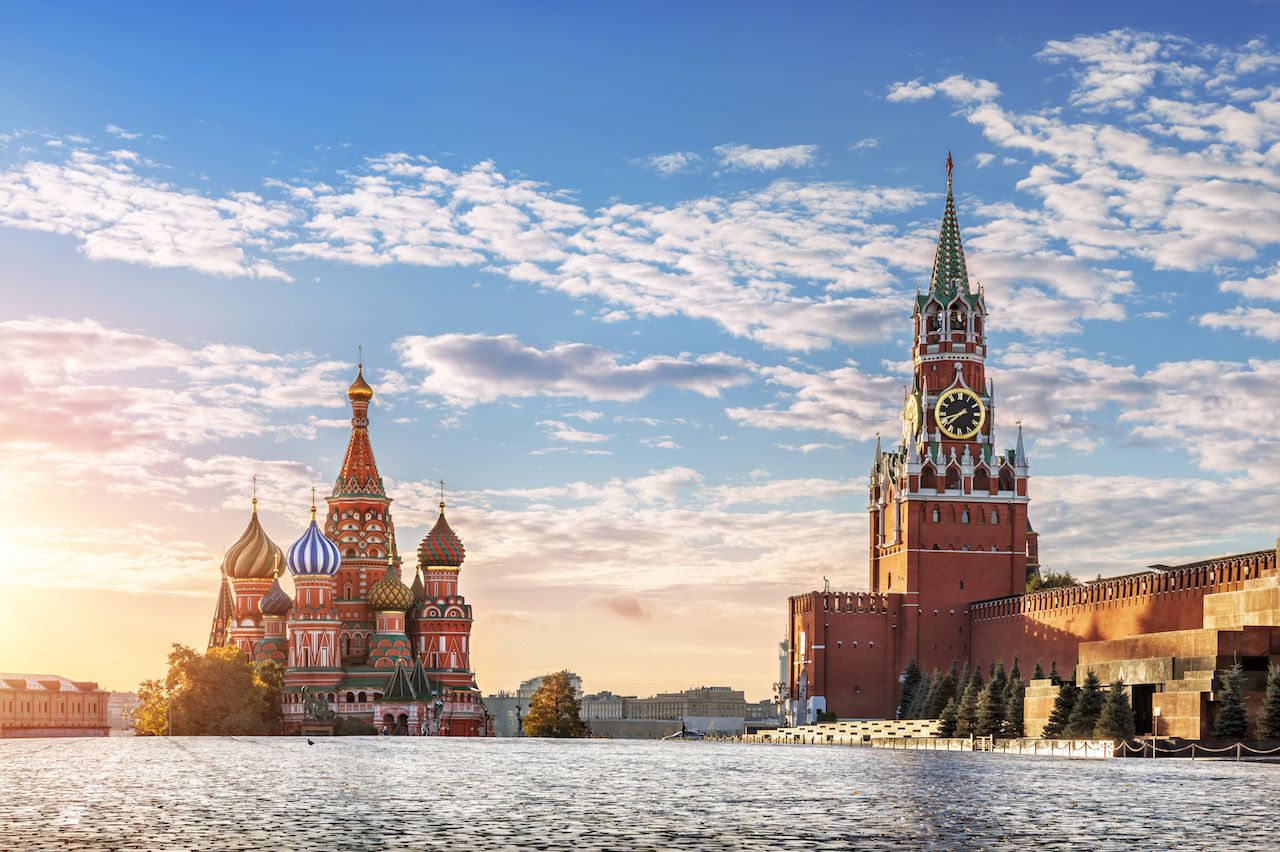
[969,550,1276,677]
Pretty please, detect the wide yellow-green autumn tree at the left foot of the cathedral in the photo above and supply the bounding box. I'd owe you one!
[133,645,283,737]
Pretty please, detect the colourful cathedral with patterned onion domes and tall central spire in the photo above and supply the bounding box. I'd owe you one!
[209,366,492,737]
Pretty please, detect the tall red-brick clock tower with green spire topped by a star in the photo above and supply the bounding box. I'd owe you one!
[868,155,1037,670]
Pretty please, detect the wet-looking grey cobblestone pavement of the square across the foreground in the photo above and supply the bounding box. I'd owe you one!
[0,737,1280,852]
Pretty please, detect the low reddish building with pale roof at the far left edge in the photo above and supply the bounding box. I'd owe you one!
[0,674,109,738]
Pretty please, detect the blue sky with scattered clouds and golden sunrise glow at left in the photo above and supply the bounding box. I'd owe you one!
[0,3,1280,700]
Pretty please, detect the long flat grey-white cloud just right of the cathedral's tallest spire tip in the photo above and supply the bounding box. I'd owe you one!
[396,334,754,406]
